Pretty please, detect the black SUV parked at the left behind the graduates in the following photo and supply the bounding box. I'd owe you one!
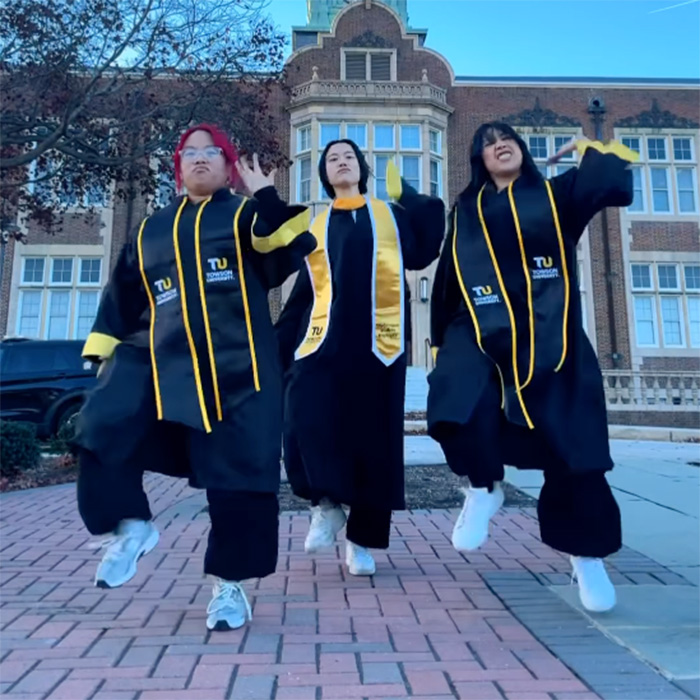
[0,338,97,437]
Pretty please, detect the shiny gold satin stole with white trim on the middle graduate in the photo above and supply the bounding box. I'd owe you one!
[295,196,405,366]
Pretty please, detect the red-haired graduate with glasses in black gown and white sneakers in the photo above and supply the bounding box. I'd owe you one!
[76,125,315,630]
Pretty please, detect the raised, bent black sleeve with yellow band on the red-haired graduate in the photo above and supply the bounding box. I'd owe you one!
[240,187,316,289]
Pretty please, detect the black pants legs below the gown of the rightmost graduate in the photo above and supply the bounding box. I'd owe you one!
[439,419,622,558]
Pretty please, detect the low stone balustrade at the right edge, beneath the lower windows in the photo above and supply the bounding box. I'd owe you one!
[603,370,700,412]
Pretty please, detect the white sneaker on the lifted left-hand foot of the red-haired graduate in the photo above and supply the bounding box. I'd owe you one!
[95,520,160,588]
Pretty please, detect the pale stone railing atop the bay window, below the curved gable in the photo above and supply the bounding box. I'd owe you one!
[292,79,448,109]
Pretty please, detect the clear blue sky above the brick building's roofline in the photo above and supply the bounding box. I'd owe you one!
[268,0,700,78]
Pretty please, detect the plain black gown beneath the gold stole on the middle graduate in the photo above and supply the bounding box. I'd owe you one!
[277,189,445,510]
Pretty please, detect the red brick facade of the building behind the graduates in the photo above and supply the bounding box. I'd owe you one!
[0,0,700,420]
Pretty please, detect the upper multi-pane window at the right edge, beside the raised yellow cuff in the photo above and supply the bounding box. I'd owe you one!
[621,134,699,215]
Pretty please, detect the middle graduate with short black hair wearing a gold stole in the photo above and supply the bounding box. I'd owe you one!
[277,140,445,576]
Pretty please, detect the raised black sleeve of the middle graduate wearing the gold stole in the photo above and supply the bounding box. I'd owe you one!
[390,179,445,270]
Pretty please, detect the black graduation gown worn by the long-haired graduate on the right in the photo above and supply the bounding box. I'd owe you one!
[428,143,633,473]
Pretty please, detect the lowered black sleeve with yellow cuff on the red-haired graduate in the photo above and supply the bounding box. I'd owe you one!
[83,229,148,362]
